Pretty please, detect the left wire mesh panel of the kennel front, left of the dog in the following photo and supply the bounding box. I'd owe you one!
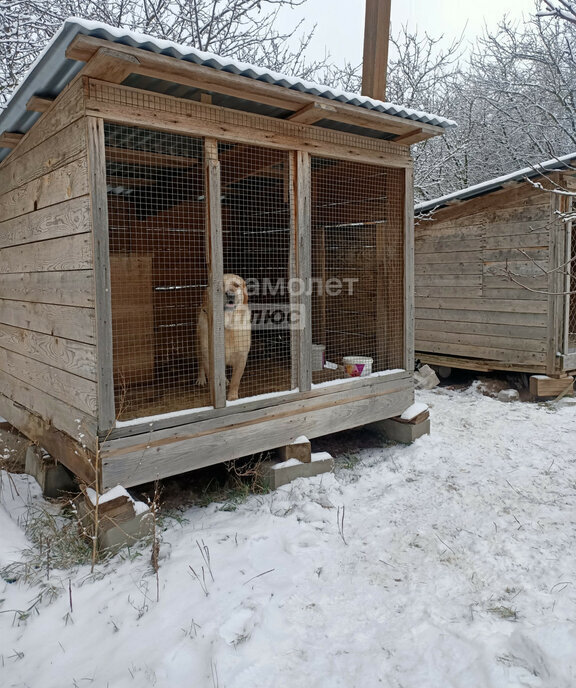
[105,124,211,420]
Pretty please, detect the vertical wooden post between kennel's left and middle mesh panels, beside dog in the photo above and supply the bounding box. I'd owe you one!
[204,138,226,408]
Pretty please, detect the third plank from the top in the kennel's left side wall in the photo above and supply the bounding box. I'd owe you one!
[0,157,88,221]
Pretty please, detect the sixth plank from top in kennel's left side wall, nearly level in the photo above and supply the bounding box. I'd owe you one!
[0,270,94,308]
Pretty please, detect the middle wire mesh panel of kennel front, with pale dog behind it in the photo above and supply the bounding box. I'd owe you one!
[218,142,293,401]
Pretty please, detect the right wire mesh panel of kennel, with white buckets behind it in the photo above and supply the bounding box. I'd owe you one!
[311,157,404,383]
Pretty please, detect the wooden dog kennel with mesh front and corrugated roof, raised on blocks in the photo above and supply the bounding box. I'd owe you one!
[0,20,453,489]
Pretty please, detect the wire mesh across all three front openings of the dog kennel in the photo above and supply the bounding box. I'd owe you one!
[105,124,404,420]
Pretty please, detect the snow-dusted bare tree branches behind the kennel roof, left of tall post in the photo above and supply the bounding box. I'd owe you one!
[0,0,327,106]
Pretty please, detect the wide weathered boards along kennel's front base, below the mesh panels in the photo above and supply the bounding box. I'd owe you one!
[102,380,413,488]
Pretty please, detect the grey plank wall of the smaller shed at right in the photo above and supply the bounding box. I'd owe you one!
[415,184,550,371]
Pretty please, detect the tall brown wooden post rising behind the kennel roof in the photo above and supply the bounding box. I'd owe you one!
[362,0,391,100]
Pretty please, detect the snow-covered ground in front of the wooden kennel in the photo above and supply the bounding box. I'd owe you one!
[0,384,576,688]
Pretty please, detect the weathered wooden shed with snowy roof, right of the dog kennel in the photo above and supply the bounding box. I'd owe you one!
[415,154,576,377]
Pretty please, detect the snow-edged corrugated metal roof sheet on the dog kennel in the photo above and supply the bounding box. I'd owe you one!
[0,17,456,160]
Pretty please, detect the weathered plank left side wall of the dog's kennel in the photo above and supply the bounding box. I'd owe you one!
[0,84,97,464]
